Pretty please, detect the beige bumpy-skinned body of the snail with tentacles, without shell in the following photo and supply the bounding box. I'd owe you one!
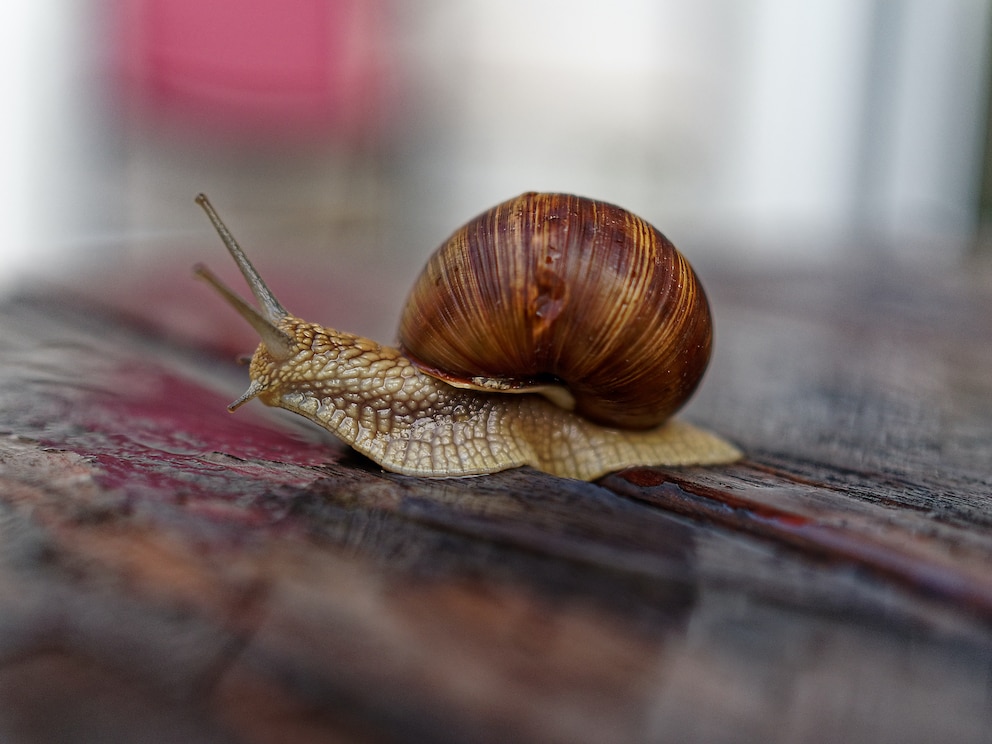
[197,195,740,480]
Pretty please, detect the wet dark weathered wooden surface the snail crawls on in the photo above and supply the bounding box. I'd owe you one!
[0,253,992,744]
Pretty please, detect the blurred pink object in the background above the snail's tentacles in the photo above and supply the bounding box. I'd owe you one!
[114,0,393,144]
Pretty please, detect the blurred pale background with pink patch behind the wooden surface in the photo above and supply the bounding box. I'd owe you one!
[0,0,992,330]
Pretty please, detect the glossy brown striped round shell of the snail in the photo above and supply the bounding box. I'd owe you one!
[399,193,712,428]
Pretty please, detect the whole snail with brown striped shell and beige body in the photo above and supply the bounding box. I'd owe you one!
[195,193,741,480]
